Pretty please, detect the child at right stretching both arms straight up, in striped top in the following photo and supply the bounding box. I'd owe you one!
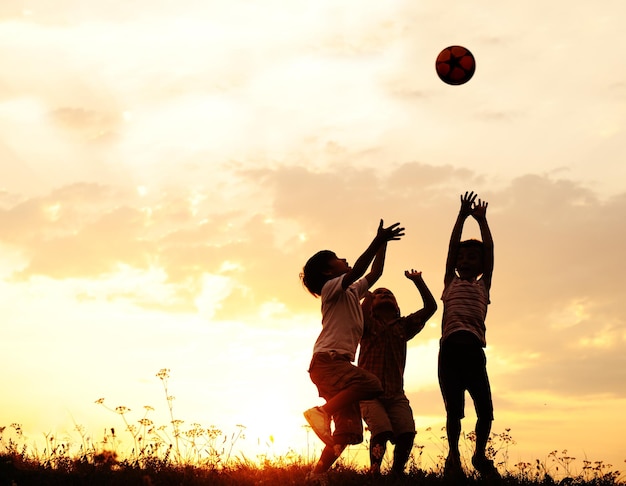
[438,192,499,481]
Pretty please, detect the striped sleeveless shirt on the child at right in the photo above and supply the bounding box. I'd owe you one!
[441,276,490,347]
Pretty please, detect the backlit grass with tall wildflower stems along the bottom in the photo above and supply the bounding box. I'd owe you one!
[0,369,626,486]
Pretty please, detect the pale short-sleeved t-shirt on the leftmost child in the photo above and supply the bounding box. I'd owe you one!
[313,274,369,361]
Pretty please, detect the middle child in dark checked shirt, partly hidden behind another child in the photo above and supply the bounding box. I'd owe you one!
[359,270,437,477]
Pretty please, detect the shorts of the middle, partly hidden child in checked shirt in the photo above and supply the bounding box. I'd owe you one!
[361,393,415,437]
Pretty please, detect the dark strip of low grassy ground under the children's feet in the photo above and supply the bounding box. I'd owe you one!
[0,454,624,486]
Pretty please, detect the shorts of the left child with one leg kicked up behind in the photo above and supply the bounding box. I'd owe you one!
[309,351,382,444]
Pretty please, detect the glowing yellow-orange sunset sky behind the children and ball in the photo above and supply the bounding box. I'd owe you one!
[0,0,626,467]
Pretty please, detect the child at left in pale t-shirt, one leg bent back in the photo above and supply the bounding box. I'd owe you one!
[300,219,404,483]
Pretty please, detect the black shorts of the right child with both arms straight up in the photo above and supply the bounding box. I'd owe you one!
[438,331,493,420]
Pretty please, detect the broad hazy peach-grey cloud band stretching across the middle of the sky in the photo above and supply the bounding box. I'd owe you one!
[0,163,625,350]
